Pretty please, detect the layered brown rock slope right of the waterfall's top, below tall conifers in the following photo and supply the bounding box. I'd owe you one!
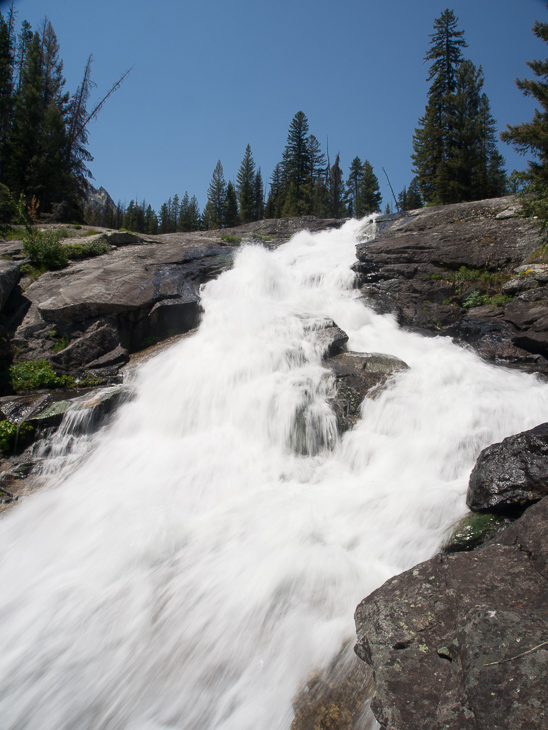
[355,197,548,372]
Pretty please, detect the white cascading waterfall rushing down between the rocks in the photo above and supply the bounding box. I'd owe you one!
[0,221,548,730]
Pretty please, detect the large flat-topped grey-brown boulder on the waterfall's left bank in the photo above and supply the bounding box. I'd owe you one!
[13,234,238,372]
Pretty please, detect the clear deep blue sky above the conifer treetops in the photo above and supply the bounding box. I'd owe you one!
[0,0,548,210]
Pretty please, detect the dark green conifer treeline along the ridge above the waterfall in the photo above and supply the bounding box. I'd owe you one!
[0,6,544,234]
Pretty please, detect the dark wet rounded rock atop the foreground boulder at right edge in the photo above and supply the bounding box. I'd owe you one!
[466,423,548,514]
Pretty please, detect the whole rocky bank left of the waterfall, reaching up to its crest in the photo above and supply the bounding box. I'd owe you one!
[0,216,342,377]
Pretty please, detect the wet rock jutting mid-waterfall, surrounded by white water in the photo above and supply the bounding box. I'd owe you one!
[325,352,408,433]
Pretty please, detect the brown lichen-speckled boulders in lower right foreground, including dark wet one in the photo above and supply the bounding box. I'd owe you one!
[355,424,548,730]
